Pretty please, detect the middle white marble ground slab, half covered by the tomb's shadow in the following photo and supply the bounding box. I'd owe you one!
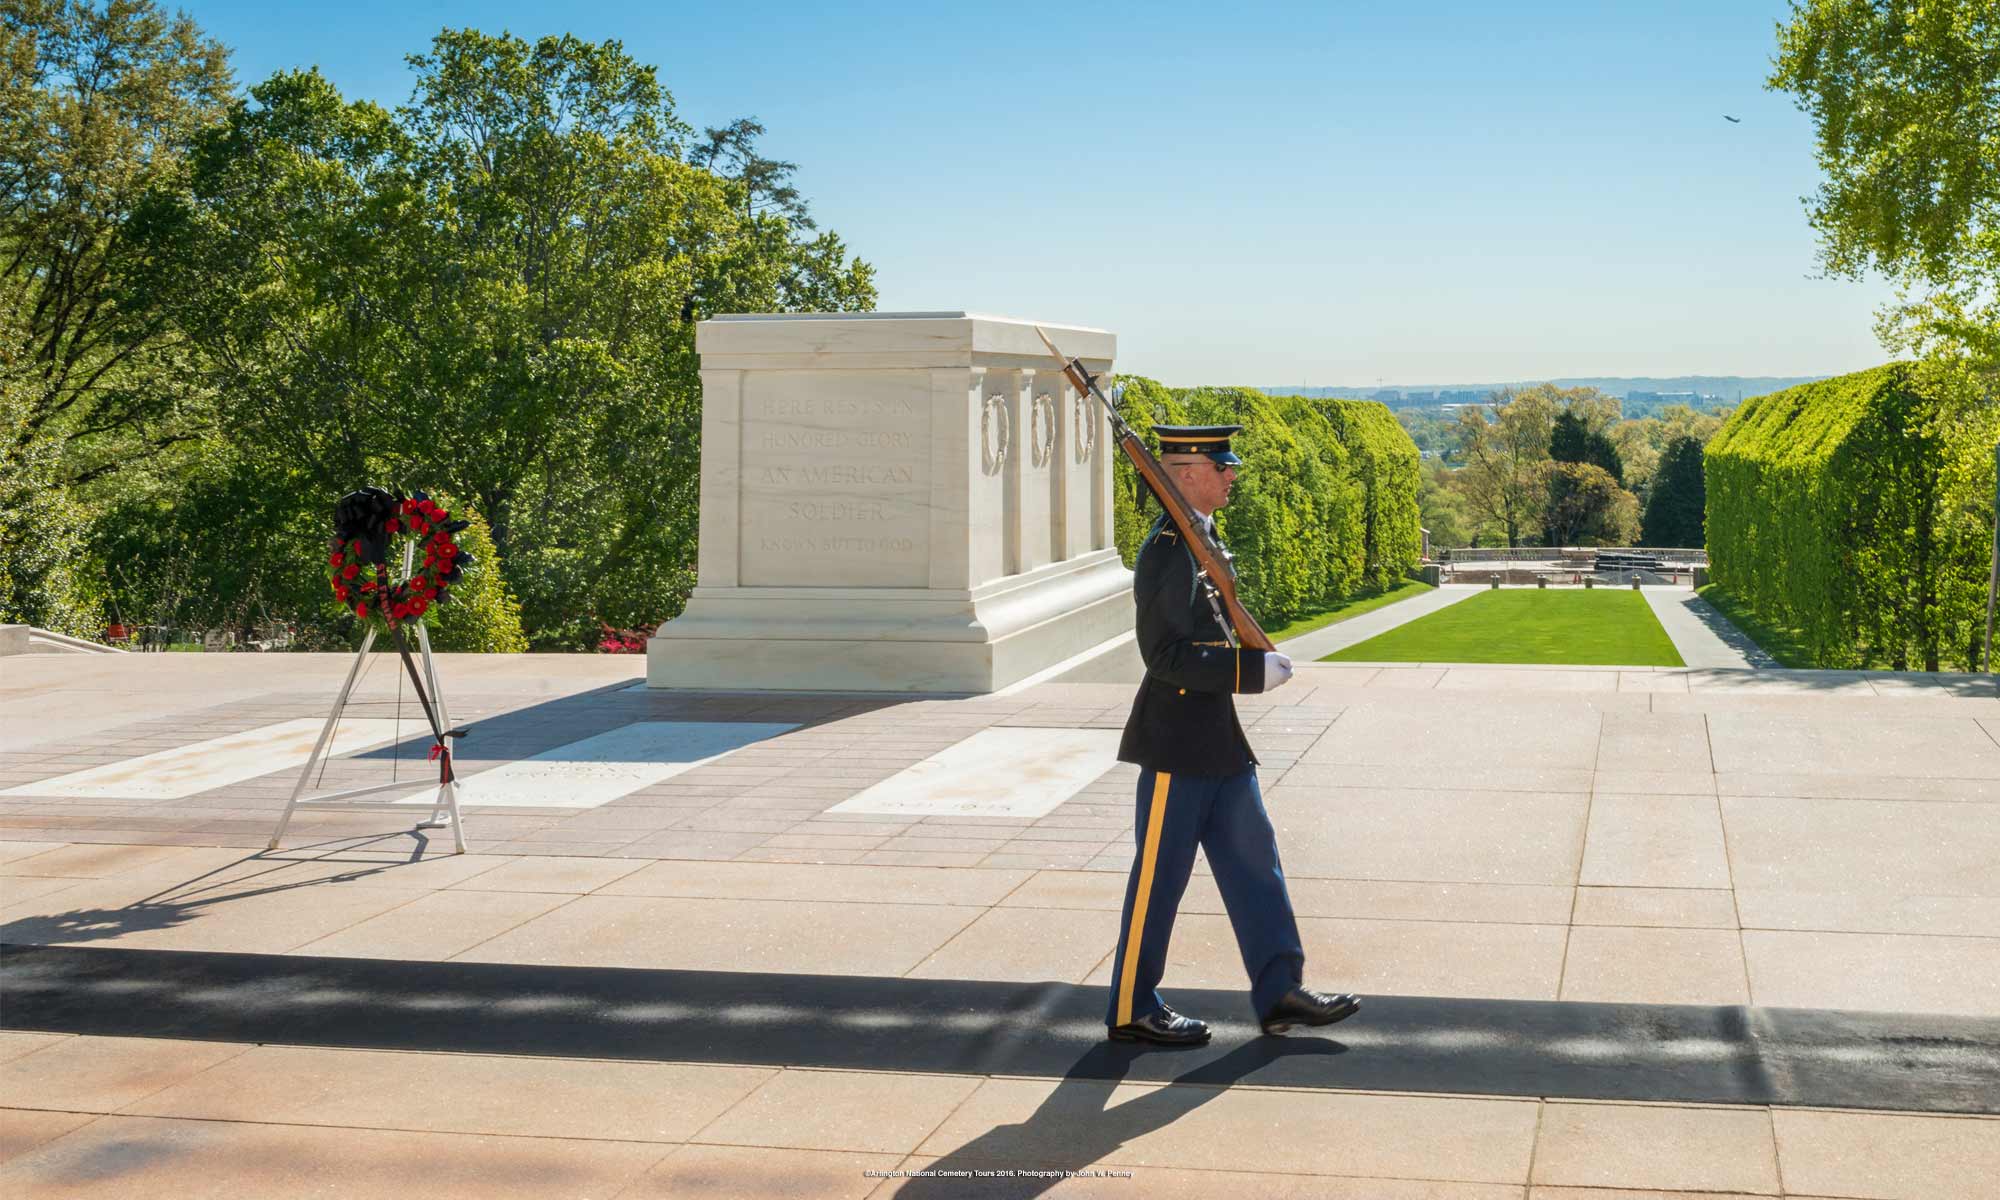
[400,720,798,808]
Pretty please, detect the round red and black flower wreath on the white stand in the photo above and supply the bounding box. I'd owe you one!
[326,488,472,630]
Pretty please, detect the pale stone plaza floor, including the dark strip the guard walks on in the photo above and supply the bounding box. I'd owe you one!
[0,656,2000,1200]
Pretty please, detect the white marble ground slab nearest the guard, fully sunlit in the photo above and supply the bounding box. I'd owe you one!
[828,728,1120,816]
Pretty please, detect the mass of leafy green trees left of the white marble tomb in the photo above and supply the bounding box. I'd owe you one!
[0,9,874,648]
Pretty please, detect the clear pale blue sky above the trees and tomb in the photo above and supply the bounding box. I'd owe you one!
[168,0,1888,384]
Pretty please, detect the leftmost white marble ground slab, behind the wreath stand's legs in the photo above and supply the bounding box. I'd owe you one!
[0,716,410,800]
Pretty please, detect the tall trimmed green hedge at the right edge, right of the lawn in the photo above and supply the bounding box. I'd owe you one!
[1704,362,2000,670]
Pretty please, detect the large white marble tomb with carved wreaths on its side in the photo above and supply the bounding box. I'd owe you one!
[648,312,1130,692]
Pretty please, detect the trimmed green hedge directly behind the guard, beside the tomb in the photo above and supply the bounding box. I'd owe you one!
[1114,376,1422,628]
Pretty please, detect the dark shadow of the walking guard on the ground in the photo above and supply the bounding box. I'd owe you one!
[894,1038,1348,1200]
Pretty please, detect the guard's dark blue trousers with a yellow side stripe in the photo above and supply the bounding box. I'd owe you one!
[1104,766,1306,1026]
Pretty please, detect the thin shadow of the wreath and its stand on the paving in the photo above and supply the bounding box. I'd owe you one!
[0,830,450,946]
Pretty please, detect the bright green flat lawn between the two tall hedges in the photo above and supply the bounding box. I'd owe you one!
[1320,588,1686,666]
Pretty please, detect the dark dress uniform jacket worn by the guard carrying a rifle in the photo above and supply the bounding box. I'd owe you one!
[1118,514,1264,776]
